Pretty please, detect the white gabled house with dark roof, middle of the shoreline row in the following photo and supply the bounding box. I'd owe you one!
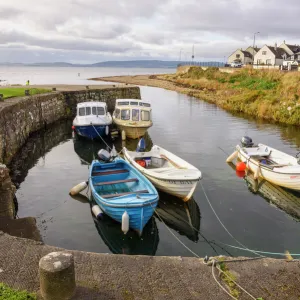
[254,44,288,66]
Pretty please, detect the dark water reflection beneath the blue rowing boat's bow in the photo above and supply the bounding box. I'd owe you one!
[93,214,159,255]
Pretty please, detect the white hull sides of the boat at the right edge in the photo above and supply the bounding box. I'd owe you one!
[237,146,300,190]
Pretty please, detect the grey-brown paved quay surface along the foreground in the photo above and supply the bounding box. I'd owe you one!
[0,232,300,300]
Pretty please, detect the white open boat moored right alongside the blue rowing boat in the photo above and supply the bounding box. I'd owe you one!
[123,145,201,201]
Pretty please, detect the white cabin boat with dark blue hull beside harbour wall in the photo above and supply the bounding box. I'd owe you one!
[73,101,112,139]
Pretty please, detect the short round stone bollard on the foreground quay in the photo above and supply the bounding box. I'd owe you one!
[39,251,76,300]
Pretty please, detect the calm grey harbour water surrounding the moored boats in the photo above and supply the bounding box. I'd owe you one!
[10,68,300,256]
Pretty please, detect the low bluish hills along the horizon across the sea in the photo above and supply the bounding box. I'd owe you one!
[0,60,222,69]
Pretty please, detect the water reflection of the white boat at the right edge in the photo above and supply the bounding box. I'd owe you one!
[244,173,300,220]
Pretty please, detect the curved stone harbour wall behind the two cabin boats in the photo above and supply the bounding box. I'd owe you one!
[0,87,141,164]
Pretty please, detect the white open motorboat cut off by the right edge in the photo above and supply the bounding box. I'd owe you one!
[227,137,300,190]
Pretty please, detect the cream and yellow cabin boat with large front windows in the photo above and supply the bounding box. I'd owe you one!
[113,99,152,139]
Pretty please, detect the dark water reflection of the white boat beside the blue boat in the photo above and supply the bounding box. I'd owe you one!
[155,192,201,242]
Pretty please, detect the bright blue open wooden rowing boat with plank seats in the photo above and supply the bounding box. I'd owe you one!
[89,157,159,234]
